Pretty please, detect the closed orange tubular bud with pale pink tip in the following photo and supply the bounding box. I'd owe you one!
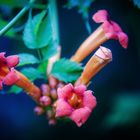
[75,47,112,85]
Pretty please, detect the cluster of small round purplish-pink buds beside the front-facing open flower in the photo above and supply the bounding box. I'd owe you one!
[34,76,64,125]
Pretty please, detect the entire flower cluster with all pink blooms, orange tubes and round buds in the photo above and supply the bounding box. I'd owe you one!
[0,10,128,127]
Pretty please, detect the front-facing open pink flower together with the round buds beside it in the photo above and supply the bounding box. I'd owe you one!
[34,81,97,127]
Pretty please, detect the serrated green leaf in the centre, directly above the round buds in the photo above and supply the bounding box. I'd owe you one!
[51,59,83,83]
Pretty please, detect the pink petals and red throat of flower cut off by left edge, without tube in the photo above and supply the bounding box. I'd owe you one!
[0,52,19,90]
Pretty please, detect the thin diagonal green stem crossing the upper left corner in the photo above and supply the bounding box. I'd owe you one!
[0,0,35,36]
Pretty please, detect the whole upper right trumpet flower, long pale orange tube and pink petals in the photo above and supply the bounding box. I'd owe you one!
[71,10,128,62]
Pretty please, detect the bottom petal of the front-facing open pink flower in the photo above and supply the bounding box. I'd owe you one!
[70,107,91,127]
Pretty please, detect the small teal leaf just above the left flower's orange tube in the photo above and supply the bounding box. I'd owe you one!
[21,67,43,81]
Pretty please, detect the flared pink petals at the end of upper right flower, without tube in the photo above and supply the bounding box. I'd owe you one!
[92,10,128,48]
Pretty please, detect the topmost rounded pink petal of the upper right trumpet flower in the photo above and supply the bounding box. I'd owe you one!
[92,10,108,23]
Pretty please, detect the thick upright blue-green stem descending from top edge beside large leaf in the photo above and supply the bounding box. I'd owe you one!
[48,0,60,45]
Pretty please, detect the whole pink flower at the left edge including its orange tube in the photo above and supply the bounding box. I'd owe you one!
[0,52,41,102]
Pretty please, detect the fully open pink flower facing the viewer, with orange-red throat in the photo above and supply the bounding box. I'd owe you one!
[55,84,96,127]
